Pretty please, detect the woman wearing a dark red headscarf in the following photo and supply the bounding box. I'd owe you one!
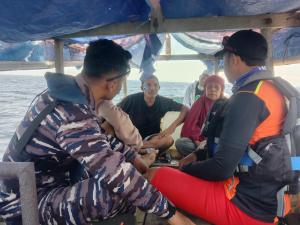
[175,75,224,156]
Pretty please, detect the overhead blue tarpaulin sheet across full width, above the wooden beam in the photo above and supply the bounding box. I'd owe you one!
[0,0,300,42]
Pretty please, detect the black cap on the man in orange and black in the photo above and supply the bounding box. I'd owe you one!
[215,30,268,61]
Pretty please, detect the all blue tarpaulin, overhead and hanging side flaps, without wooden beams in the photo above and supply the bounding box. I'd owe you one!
[0,0,300,74]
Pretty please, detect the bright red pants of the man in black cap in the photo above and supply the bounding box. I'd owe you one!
[151,167,274,225]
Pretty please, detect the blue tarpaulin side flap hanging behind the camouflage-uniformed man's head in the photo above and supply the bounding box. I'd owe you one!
[0,34,165,74]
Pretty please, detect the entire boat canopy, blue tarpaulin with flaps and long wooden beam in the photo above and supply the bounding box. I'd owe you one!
[0,0,300,72]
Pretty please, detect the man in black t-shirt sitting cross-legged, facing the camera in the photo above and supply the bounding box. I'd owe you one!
[119,75,188,150]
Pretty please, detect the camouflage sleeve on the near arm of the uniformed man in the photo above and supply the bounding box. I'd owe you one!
[56,104,175,218]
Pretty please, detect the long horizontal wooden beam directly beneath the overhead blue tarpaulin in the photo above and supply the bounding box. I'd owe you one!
[58,12,300,38]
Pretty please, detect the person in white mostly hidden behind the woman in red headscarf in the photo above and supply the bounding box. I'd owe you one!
[183,70,209,108]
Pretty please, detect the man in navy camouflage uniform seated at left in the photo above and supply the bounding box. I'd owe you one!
[1,40,192,225]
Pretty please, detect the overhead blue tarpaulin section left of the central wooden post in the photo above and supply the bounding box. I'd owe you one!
[0,0,150,42]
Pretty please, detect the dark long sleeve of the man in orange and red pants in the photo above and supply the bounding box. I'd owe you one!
[183,93,269,181]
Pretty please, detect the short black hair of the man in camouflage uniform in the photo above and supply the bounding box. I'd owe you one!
[82,39,132,78]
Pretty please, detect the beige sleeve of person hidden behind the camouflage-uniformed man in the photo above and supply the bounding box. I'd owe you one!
[98,101,143,149]
